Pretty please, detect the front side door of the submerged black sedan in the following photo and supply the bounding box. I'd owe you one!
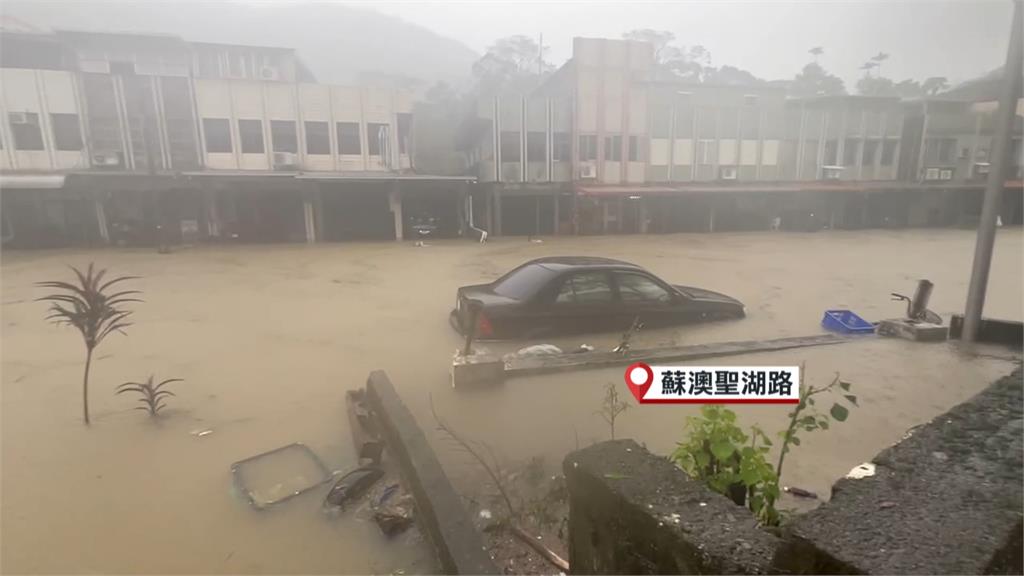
[614,271,691,328]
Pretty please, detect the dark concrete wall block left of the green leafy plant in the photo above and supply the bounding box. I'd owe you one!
[563,440,778,574]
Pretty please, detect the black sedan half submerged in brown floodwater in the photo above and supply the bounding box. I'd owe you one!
[451,256,744,338]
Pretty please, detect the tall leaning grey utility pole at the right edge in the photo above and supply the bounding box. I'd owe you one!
[961,0,1024,342]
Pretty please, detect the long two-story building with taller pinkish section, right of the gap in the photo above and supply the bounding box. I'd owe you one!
[474,38,1021,234]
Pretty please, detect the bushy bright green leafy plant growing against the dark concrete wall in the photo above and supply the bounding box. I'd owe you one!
[670,405,779,526]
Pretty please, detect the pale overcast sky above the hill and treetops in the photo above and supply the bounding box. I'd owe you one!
[348,0,1013,85]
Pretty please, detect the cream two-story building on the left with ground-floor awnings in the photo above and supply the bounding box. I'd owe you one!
[0,31,472,245]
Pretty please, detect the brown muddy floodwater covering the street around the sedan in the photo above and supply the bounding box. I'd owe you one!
[0,229,1024,573]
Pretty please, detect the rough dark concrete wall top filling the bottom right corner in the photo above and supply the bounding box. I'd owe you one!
[778,368,1024,574]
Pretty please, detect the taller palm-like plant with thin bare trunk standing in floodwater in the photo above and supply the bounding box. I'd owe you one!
[37,262,141,424]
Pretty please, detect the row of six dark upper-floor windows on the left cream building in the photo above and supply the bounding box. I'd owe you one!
[203,118,391,156]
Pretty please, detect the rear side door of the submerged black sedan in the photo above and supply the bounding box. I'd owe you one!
[544,271,615,334]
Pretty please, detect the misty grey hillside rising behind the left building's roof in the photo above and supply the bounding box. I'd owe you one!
[0,0,477,84]
